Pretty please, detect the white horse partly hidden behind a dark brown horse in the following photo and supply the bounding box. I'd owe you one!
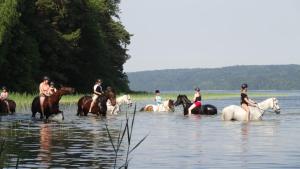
[106,94,132,114]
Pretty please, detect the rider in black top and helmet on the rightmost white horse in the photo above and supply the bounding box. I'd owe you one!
[241,83,257,121]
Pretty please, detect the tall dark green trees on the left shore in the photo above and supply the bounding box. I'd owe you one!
[0,0,130,92]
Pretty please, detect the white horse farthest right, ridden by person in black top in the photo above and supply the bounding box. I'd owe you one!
[222,98,280,121]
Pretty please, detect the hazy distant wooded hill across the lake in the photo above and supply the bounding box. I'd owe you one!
[128,65,300,91]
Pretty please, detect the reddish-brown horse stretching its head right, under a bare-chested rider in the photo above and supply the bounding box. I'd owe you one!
[31,87,75,120]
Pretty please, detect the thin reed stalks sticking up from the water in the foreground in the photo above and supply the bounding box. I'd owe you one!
[105,104,148,169]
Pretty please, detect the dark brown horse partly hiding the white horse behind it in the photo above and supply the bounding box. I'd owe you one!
[77,87,117,116]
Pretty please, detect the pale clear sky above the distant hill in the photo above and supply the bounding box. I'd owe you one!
[120,0,300,72]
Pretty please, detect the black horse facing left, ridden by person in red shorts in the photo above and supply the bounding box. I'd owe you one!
[174,95,218,115]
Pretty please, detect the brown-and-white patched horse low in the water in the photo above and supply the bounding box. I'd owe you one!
[140,99,175,112]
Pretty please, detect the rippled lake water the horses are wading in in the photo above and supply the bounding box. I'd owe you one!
[0,92,300,169]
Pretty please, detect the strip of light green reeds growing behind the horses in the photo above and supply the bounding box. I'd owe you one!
[9,91,288,107]
